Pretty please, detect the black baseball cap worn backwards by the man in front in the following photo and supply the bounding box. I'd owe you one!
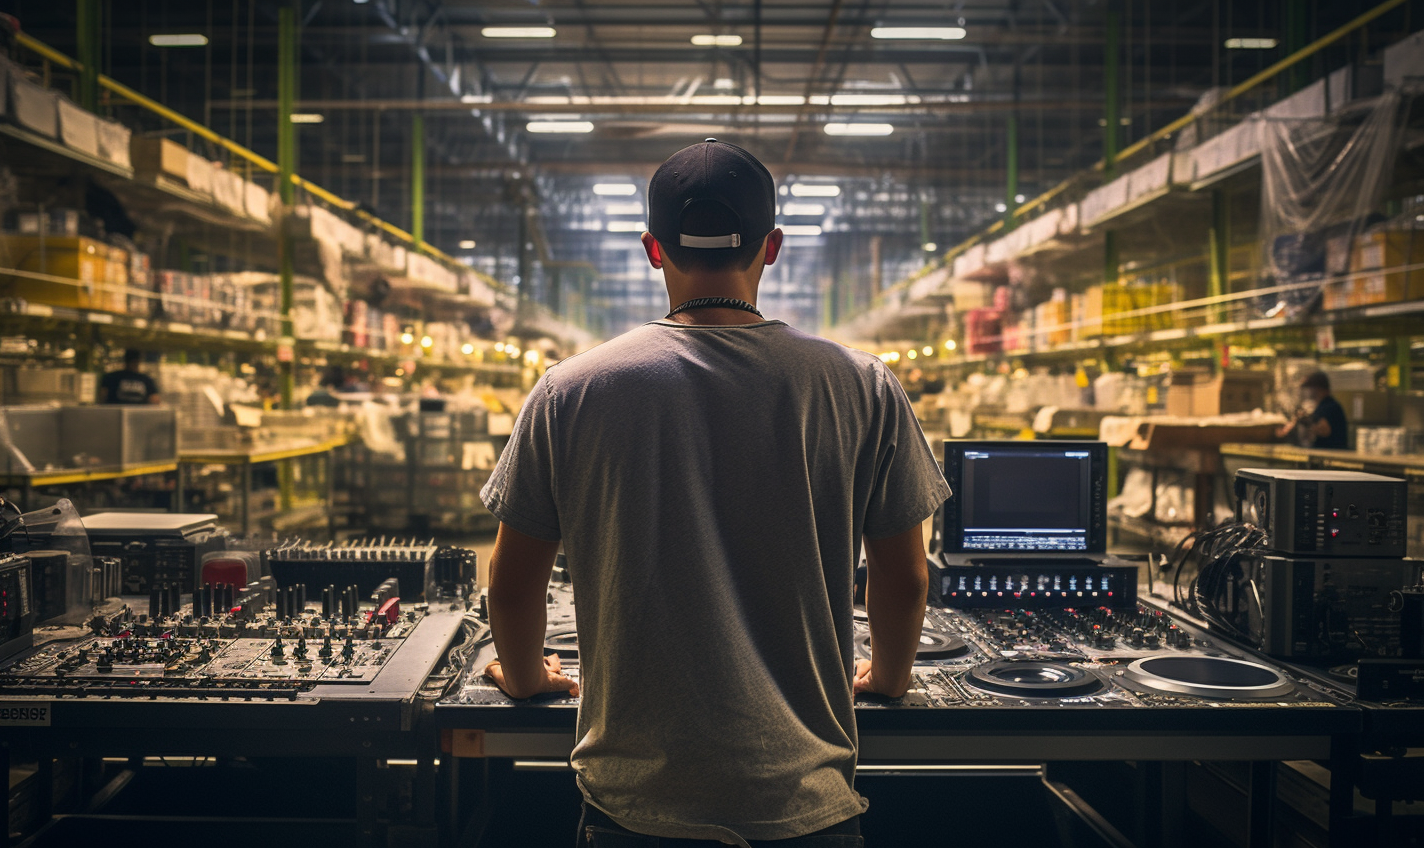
[648,138,776,248]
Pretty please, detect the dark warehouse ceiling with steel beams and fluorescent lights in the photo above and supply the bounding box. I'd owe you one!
[0,0,1368,341]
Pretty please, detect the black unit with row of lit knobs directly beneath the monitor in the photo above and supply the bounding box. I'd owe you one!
[938,559,1138,609]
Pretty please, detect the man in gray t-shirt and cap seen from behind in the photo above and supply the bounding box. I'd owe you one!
[481,139,950,848]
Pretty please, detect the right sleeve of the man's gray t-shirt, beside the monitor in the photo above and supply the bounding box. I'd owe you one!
[864,363,950,539]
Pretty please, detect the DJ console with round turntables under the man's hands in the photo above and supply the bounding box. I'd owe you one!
[441,585,1340,710]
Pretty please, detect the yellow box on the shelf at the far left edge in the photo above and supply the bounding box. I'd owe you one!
[0,235,128,313]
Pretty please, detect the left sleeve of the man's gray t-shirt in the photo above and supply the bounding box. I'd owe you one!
[480,374,561,542]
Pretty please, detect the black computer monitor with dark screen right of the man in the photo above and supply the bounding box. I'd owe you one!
[936,440,1108,556]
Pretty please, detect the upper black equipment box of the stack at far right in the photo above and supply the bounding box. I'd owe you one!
[1236,468,1405,558]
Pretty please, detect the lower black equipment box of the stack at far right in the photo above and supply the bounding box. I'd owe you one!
[1253,555,1420,657]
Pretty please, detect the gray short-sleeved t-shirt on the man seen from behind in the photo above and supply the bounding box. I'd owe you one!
[481,322,950,839]
